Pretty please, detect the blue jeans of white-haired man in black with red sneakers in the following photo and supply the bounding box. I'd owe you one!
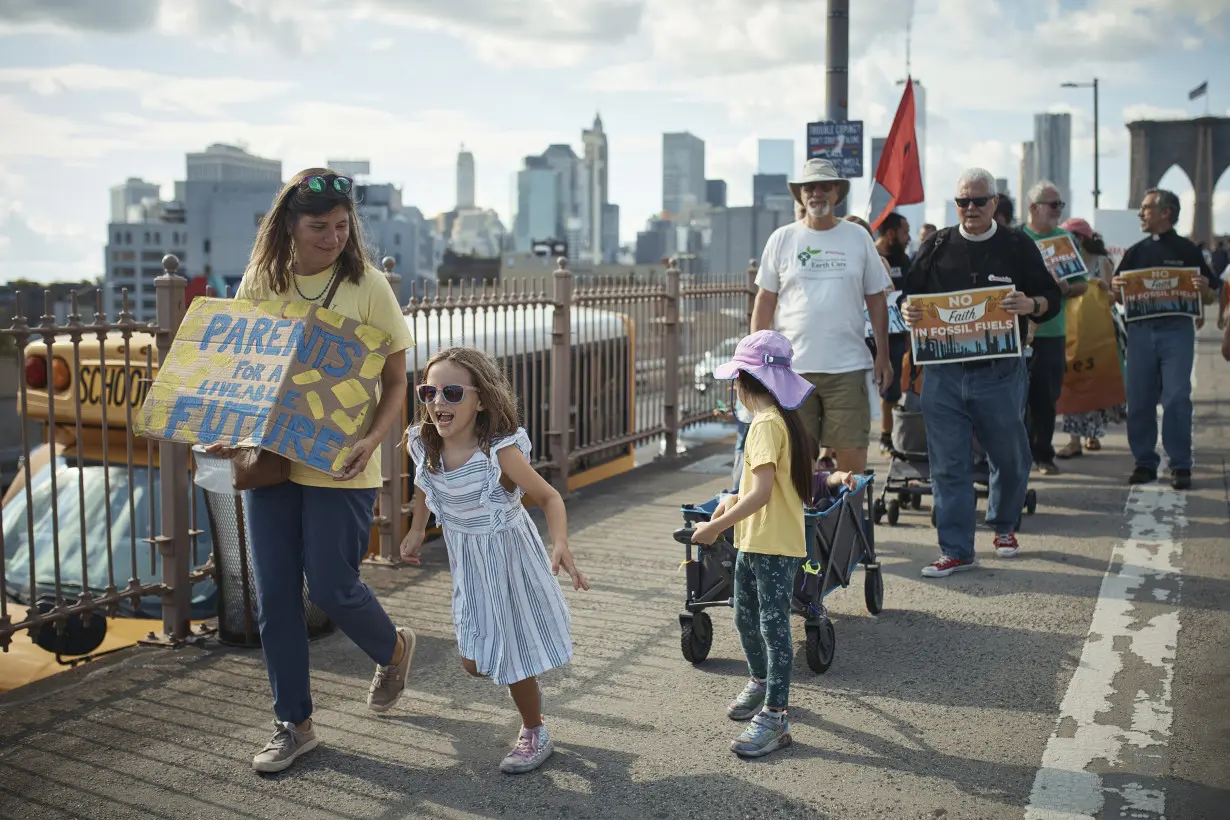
[923,359,1030,561]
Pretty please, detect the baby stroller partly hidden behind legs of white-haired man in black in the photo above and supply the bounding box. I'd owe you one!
[872,353,1038,530]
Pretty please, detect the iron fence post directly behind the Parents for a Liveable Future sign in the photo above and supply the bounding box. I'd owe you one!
[152,253,192,645]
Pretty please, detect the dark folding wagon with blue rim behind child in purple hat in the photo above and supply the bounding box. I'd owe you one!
[674,472,884,674]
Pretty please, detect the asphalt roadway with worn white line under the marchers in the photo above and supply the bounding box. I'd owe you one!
[0,328,1230,820]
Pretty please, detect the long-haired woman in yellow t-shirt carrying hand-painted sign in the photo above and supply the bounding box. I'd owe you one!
[209,168,415,772]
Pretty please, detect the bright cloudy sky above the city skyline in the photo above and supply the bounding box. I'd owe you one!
[0,0,1230,282]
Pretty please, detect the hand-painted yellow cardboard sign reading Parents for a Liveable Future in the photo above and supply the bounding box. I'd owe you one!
[133,298,391,476]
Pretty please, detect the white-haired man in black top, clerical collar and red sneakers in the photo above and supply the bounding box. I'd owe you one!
[903,168,1060,578]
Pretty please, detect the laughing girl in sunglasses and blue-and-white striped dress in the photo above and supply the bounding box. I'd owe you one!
[401,348,589,773]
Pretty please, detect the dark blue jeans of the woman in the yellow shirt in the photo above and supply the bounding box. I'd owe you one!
[244,481,397,723]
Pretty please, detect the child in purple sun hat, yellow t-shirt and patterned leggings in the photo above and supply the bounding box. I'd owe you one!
[692,331,815,757]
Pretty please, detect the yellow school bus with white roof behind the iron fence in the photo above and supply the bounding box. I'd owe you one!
[0,305,636,691]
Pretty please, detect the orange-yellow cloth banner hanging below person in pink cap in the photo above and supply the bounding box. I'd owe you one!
[1055,286,1128,416]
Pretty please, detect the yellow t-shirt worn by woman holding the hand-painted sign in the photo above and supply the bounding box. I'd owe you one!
[235,266,415,489]
